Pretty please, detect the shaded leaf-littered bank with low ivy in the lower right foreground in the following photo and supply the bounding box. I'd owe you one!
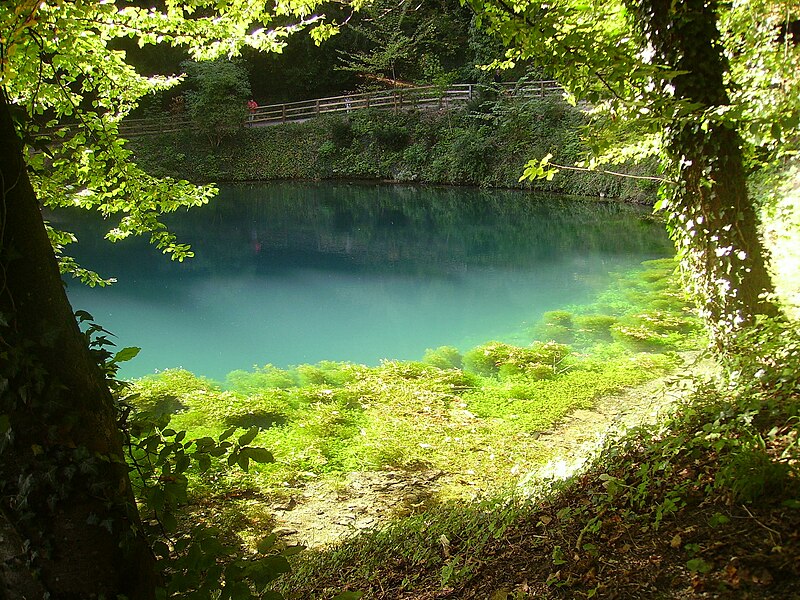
[282,328,800,600]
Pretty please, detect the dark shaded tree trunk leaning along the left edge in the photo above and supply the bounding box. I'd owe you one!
[0,93,156,600]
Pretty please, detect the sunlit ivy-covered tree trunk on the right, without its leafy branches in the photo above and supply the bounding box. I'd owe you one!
[635,0,777,349]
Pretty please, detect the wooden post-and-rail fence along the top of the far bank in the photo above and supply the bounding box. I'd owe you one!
[120,80,563,137]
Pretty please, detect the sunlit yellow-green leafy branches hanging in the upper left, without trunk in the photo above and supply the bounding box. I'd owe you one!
[0,0,335,274]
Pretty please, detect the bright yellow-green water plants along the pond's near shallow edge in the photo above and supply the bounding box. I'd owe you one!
[123,259,703,524]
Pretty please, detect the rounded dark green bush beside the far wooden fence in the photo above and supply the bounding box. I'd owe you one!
[181,60,251,147]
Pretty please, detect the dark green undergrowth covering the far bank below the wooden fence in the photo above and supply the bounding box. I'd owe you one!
[129,97,655,202]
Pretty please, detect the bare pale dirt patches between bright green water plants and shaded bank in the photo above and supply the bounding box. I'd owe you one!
[271,353,713,547]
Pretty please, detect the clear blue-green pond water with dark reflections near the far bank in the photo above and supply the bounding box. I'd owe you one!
[59,183,671,379]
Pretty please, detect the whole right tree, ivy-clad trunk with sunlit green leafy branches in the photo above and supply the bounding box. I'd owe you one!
[467,0,800,348]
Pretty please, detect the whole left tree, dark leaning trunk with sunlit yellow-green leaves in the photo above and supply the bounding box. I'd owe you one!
[0,0,331,599]
